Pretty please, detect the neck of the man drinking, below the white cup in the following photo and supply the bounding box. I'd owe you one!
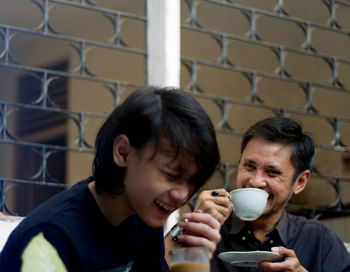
[249,210,283,243]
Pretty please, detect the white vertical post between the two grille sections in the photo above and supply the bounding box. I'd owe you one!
[147,0,180,87]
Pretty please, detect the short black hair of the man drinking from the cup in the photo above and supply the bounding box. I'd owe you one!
[241,116,315,180]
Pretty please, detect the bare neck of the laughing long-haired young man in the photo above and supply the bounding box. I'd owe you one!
[88,181,134,226]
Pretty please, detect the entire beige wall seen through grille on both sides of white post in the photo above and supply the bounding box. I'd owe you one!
[0,0,350,241]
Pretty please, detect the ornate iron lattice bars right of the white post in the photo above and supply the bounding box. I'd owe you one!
[182,0,350,218]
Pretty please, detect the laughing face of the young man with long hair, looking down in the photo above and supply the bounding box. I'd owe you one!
[124,140,196,227]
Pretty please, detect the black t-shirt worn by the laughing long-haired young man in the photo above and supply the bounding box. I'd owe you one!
[0,179,169,272]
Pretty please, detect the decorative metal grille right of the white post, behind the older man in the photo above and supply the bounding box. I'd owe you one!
[182,0,350,218]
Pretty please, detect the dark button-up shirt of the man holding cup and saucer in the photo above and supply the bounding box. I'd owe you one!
[211,213,350,272]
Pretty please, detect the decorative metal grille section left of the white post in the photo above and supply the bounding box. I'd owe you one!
[0,0,147,215]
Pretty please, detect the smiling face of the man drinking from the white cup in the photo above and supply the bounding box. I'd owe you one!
[237,137,295,218]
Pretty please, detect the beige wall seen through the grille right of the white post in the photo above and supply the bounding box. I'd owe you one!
[181,0,350,241]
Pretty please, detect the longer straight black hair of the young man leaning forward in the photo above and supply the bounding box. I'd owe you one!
[93,87,220,194]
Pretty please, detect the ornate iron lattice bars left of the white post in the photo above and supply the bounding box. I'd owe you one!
[0,0,147,215]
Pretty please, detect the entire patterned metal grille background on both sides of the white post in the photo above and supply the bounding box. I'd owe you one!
[0,0,350,221]
